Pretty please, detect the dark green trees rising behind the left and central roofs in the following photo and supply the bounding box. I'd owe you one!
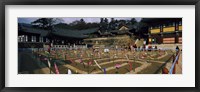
[31,18,141,32]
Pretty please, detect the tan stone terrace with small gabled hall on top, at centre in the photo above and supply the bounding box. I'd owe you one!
[84,26,134,48]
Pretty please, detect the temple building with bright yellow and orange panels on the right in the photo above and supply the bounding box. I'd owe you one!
[142,18,182,44]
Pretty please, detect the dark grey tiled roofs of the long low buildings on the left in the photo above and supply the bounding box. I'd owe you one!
[19,24,98,38]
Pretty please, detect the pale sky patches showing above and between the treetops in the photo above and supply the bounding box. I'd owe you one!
[18,17,141,24]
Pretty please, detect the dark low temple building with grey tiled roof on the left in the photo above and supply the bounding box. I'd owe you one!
[18,23,98,48]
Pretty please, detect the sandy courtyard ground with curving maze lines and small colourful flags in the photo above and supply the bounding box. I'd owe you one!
[18,45,182,74]
